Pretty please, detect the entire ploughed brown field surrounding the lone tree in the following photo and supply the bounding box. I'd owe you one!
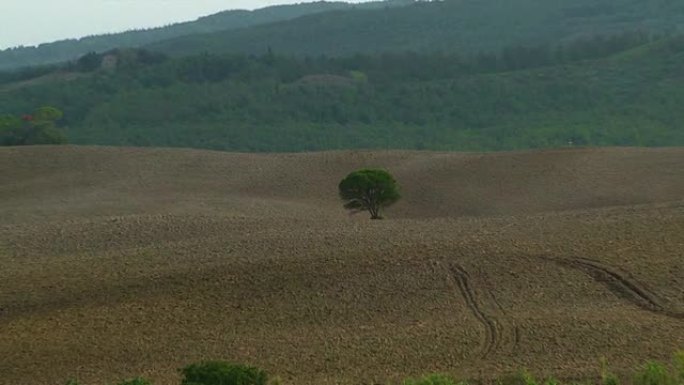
[0,147,684,385]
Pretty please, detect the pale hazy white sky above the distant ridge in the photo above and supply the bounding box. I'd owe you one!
[0,0,372,49]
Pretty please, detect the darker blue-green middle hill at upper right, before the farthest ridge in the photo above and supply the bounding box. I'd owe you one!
[149,0,684,56]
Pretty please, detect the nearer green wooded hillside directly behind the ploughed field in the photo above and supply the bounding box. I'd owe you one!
[0,34,684,151]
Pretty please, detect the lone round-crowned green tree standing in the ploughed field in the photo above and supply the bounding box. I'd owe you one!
[339,169,401,219]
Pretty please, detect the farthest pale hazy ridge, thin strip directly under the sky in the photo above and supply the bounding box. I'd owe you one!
[0,0,412,70]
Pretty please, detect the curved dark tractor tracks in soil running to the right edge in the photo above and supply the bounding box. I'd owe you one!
[543,257,684,320]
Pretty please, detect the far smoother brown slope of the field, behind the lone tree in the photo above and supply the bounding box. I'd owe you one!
[0,146,684,219]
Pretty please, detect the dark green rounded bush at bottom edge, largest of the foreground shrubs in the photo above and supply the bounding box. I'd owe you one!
[181,361,268,385]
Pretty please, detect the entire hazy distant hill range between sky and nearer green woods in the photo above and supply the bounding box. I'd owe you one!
[0,0,684,70]
